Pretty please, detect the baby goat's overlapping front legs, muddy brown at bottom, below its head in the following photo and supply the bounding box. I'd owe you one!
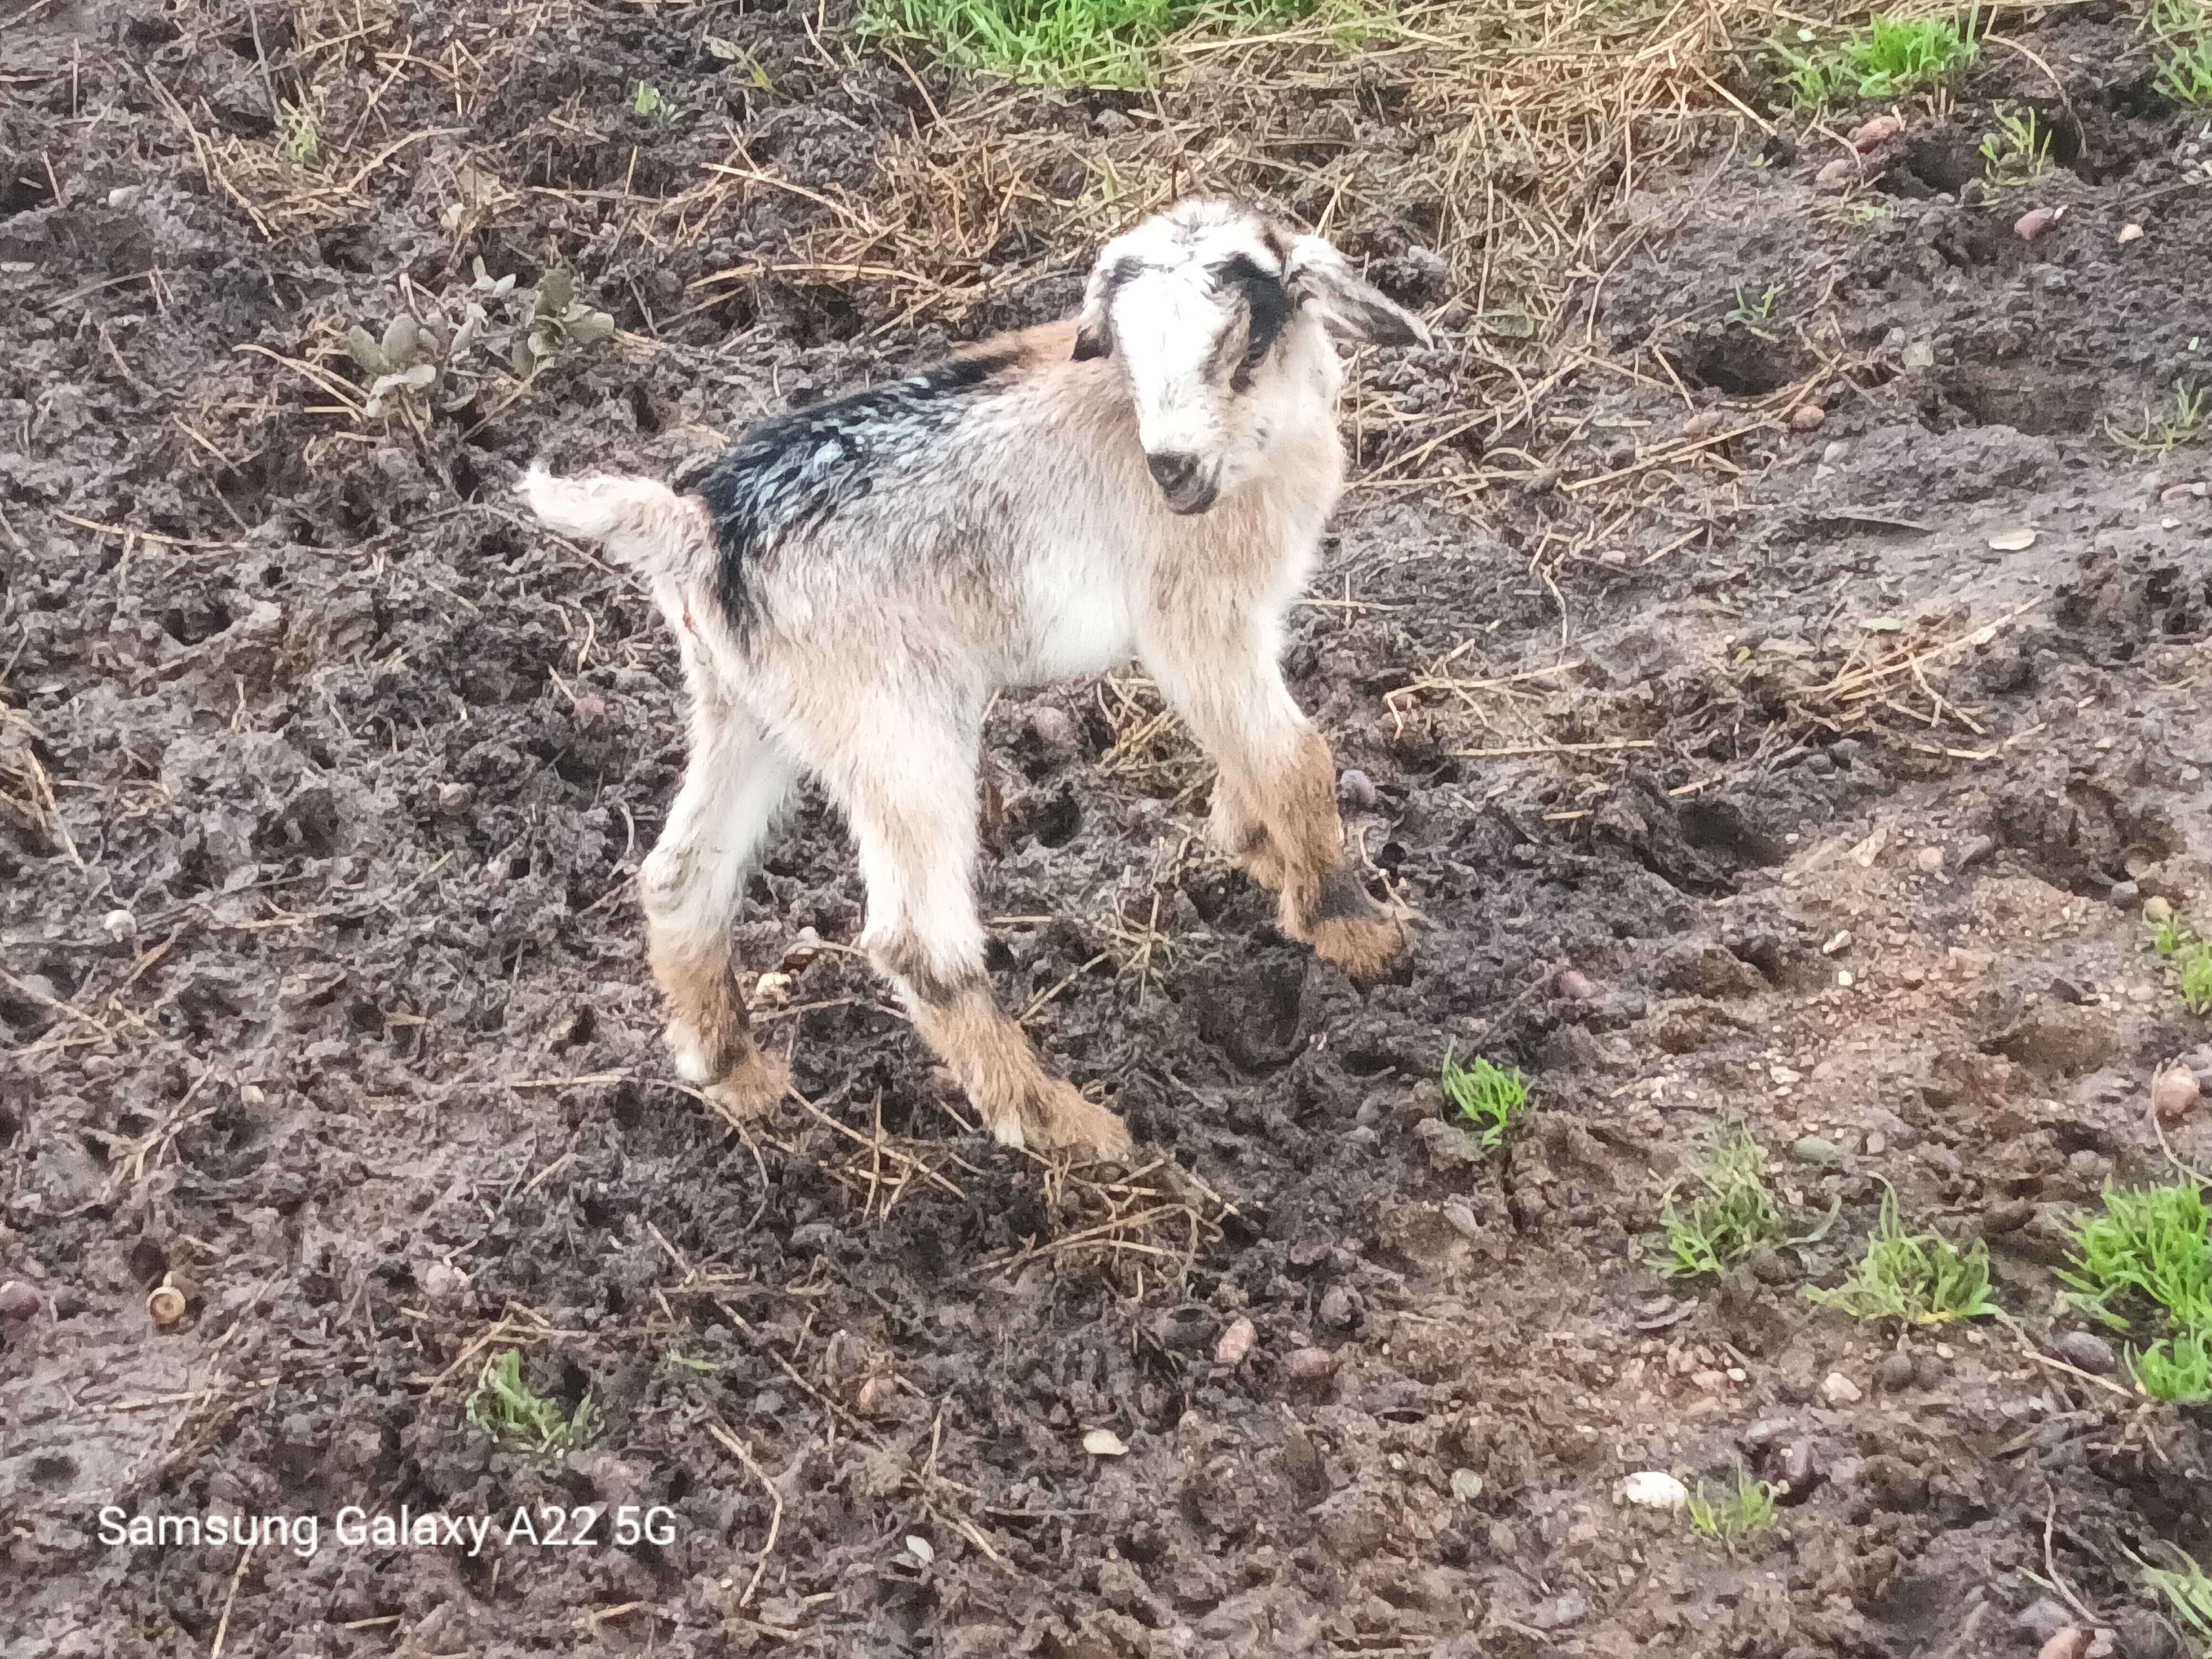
[1144,622,1407,980]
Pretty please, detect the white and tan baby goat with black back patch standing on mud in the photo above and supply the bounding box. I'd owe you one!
[522,201,1429,1157]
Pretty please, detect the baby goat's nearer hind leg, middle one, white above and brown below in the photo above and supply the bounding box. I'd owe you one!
[818,699,1130,1159]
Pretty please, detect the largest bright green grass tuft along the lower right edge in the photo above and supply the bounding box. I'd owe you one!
[2059,1177,2212,1402]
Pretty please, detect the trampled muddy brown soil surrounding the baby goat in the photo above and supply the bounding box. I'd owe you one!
[0,0,2212,1659]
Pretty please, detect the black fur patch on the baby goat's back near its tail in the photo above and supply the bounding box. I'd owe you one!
[690,352,1020,639]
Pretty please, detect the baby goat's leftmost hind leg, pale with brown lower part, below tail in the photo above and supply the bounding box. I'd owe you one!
[639,672,794,1117]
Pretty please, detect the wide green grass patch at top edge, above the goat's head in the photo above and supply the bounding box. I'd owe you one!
[858,0,1345,86]
